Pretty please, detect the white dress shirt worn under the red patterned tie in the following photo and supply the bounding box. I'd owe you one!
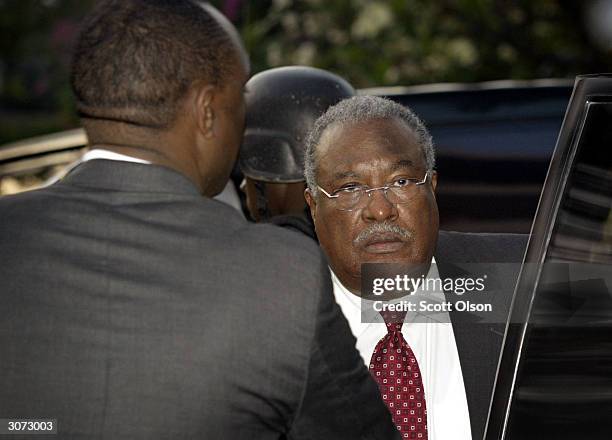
[331,260,472,440]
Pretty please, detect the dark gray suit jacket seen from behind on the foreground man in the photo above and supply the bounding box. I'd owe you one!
[0,160,397,440]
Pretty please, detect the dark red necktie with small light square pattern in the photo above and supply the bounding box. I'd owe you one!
[370,312,427,440]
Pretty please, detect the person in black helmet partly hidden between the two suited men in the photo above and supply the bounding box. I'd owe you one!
[239,66,355,236]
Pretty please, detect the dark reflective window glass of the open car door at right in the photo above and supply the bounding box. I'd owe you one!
[506,103,612,439]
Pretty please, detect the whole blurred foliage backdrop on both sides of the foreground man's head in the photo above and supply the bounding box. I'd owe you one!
[0,0,612,143]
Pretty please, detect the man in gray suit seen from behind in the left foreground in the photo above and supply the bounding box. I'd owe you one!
[0,0,396,440]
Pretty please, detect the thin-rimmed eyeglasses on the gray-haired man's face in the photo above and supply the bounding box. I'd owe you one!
[317,171,430,211]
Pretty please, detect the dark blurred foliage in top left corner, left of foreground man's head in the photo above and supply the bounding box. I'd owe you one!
[0,0,90,143]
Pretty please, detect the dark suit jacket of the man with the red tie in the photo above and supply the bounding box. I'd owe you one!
[436,231,527,440]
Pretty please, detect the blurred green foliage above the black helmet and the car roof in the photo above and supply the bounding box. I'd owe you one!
[231,0,612,87]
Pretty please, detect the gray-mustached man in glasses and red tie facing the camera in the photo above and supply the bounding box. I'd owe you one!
[305,96,525,440]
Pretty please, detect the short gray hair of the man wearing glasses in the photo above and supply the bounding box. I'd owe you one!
[304,95,436,195]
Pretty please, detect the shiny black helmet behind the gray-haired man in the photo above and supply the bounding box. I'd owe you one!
[239,66,355,183]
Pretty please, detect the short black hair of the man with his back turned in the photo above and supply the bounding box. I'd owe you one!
[71,0,236,128]
